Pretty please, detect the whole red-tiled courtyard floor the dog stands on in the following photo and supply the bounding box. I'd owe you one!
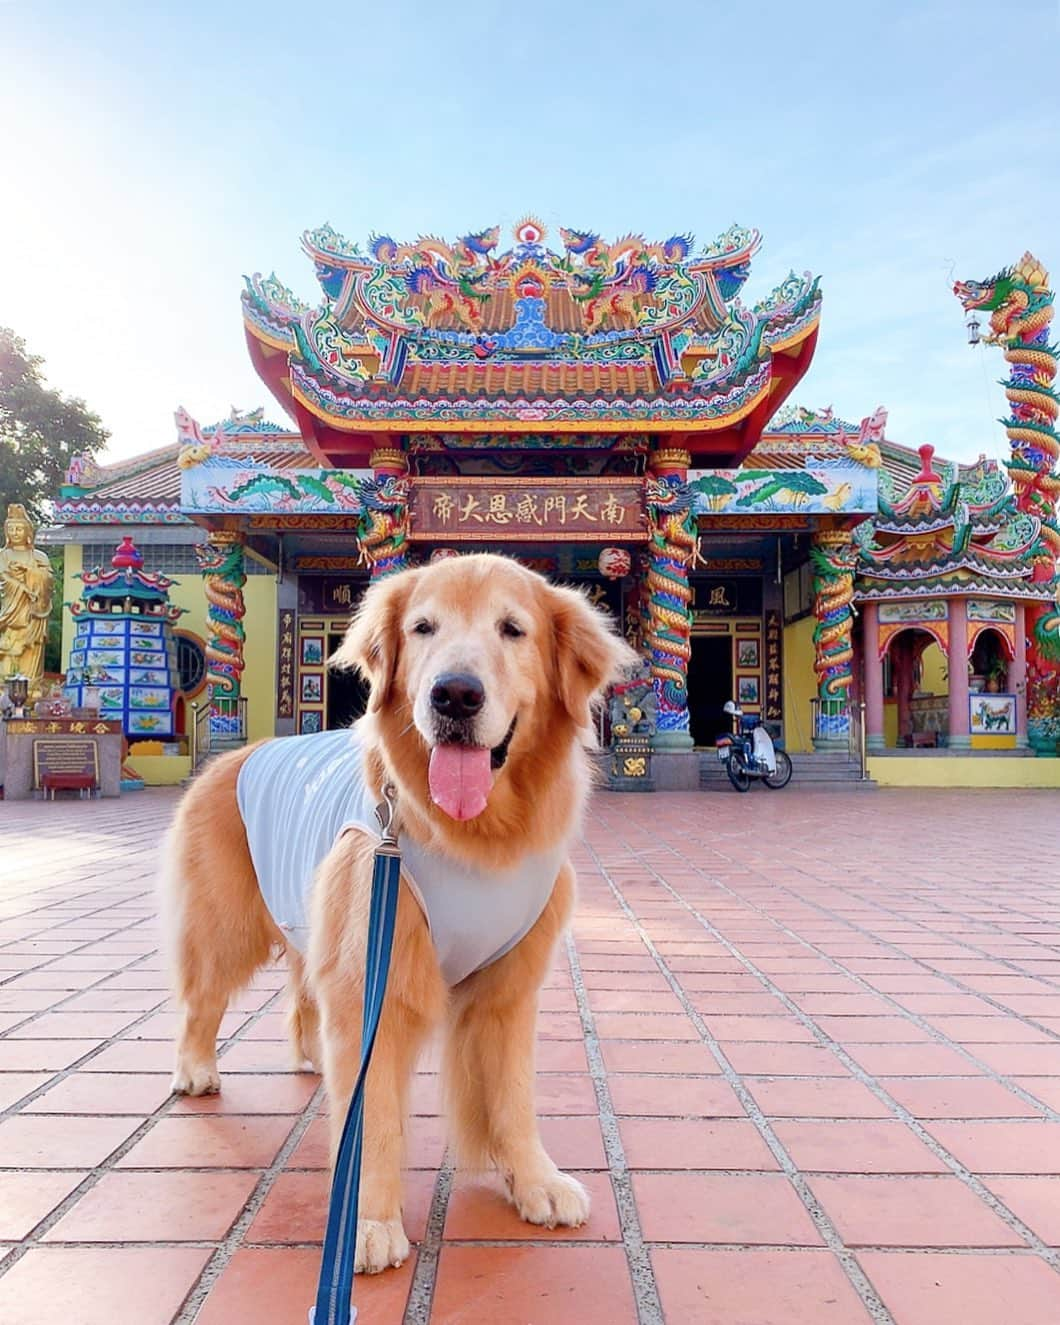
[0,788,1060,1325]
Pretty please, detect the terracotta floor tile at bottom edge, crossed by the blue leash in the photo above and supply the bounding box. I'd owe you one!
[194,1247,413,1325]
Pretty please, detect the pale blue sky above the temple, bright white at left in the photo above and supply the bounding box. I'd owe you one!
[0,0,1060,469]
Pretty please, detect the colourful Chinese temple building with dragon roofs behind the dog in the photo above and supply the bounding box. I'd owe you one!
[43,219,1060,790]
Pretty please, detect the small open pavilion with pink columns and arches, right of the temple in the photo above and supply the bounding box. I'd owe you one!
[855,445,1052,751]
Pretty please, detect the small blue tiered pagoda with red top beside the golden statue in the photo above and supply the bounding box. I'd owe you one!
[65,535,184,739]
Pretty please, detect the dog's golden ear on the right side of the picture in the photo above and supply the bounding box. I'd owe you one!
[547,584,636,727]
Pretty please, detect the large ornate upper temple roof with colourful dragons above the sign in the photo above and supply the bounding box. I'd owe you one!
[242,219,820,462]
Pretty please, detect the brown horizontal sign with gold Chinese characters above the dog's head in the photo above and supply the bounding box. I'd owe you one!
[409,478,648,543]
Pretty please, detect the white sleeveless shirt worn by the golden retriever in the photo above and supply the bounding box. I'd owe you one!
[236,726,567,987]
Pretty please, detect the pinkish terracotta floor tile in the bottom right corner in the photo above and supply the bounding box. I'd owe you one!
[857,1251,1057,1325]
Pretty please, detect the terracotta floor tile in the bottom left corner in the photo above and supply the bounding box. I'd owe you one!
[0,1247,209,1325]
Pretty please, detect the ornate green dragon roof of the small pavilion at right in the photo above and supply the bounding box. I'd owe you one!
[855,445,1052,599]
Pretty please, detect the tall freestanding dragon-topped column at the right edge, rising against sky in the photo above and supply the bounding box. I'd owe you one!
[954,253,1060,734]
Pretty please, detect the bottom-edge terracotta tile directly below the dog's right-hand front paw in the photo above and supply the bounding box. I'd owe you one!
[431,1246,636,1325]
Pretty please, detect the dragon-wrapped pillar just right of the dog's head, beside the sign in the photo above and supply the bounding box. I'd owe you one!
[647,476,696,731]
